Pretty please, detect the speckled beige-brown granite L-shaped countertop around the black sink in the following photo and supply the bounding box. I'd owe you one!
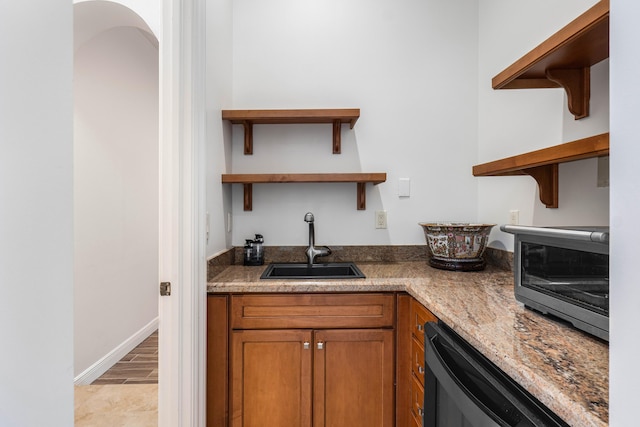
[207,261,609,427]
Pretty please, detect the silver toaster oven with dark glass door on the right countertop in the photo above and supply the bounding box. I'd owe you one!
[500,225,609,341]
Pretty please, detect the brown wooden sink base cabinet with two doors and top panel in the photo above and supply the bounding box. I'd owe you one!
[207,293,396,427]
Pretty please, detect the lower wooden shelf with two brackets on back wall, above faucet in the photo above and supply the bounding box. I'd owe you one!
[222,173,387,211]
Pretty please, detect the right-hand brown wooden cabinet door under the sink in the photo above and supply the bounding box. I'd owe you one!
[313,329,395,427]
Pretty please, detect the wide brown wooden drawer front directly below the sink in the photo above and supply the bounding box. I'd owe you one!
[231,294,395,329]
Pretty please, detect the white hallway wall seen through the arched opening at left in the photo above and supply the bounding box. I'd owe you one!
[73,22,159,375]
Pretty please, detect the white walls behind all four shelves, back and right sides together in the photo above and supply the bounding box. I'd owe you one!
[227,0,609,250]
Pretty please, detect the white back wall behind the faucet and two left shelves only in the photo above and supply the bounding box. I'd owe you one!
[226,0,478,245]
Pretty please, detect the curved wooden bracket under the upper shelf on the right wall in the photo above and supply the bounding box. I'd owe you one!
[546,67,591,120]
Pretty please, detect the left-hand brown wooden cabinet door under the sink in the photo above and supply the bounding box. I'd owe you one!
[231,330,313,427]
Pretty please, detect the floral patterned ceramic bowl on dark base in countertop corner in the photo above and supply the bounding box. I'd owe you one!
[419,222,495,271]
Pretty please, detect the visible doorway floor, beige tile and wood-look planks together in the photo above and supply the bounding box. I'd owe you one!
[75,331,158,427]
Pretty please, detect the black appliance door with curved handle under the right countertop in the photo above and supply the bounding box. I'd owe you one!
[424,322,567,427]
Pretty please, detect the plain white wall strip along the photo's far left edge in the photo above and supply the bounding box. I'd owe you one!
[0,0,73,427]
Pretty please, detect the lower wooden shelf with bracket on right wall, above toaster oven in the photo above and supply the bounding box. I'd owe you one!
[473,133,609,208]
